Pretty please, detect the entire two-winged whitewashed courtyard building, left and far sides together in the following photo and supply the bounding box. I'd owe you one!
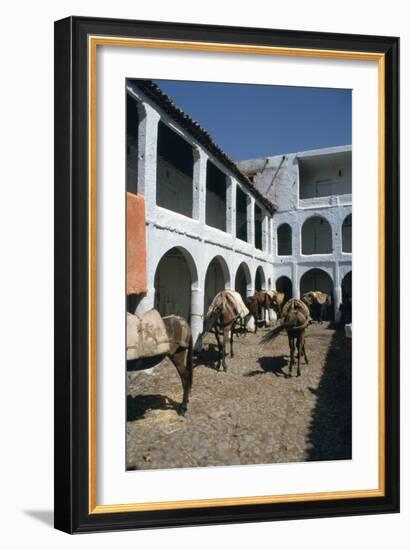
[127,80,352,341]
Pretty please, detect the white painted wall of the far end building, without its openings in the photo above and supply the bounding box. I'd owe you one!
[239,146,352,314]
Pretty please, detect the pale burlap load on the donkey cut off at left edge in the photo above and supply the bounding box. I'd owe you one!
[127,309,170,360]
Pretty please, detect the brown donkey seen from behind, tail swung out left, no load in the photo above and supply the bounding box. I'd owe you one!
[261,298,311,376]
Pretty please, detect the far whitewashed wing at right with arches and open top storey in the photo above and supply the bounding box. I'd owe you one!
[238,146,352,320]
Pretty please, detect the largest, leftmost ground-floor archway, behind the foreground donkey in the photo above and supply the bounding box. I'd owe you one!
[154,247,197,322]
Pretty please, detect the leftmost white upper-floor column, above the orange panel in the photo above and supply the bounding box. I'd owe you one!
[138,103,160,219]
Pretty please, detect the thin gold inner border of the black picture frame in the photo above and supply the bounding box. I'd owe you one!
[88,35,386,514]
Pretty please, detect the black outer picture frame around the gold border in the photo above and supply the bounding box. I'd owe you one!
[54,17,400,533]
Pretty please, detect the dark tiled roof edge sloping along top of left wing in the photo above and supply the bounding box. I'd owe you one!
[128,79,277,213]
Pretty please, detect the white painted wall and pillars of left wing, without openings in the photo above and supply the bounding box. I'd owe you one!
[128,83,274,342]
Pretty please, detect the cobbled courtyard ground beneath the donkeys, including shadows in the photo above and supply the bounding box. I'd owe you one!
[127,324,351,469]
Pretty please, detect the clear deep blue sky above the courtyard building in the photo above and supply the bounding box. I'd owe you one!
[155,80,352,160]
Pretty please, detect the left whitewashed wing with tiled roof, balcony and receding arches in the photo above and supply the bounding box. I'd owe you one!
[127,80,276,340]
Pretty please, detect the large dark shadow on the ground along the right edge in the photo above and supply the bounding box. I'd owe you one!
[307,330,352,460]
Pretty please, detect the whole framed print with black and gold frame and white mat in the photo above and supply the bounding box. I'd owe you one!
[55,17,399,533]
